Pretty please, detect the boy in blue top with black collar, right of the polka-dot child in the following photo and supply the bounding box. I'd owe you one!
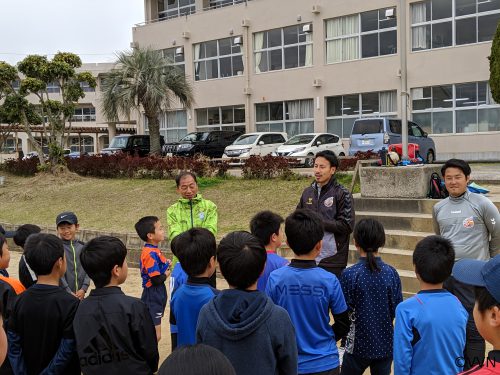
[394,236,468,375]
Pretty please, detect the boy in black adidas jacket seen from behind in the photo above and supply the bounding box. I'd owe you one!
[74,236,159,375]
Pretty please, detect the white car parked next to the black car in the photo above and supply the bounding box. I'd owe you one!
[222,132,288,163]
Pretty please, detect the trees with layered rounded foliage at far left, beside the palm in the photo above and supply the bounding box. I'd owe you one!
[0,52,96,170]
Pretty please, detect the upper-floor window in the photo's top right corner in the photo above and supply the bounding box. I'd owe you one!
[410,0,500,51]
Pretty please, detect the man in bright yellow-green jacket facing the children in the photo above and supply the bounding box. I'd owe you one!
[167,172,217,287]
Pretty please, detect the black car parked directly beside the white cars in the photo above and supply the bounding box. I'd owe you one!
[163,130,242,158]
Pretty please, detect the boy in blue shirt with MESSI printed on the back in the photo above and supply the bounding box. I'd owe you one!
[266,210,349,375]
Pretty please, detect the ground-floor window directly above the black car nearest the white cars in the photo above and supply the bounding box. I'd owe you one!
[196,105,245,131]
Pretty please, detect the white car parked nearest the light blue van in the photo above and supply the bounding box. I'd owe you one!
[275,133,346,167]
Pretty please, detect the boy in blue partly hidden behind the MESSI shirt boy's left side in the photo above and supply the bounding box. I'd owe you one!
[250,211,289,292]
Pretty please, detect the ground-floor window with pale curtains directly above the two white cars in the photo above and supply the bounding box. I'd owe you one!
[255,99,314,137]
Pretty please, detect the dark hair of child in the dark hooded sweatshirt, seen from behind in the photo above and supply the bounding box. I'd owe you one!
[218,231,267,289]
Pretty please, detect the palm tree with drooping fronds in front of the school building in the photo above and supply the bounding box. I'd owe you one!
[101,47,194,154]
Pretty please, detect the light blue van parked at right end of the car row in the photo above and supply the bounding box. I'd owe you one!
[349,117,436,163]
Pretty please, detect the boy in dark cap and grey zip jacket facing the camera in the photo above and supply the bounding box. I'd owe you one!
[56,211,90,299]
